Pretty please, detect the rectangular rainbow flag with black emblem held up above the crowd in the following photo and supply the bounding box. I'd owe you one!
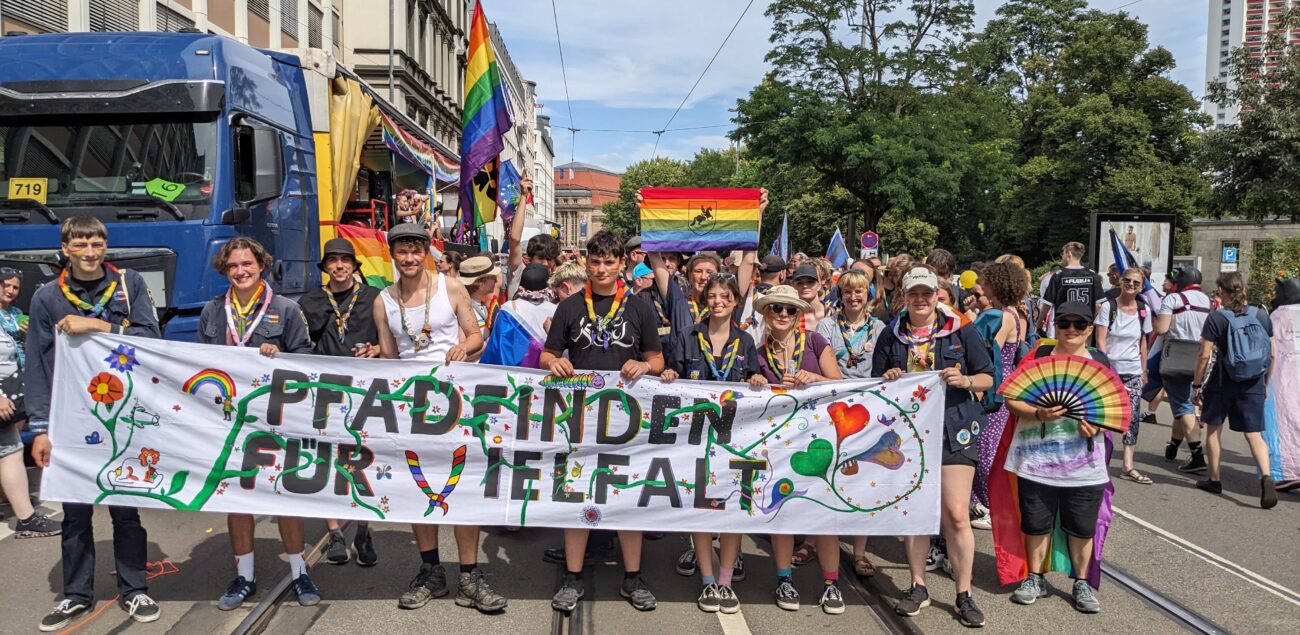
[641,187,762,251]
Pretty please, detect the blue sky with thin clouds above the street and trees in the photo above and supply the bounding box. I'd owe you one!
[482,0,1209,169]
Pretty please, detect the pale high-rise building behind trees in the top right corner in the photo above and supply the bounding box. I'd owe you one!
[1205,0,1300,125]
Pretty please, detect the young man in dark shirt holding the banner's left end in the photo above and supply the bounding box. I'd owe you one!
[23,216,163,632]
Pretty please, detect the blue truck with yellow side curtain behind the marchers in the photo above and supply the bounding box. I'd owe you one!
[0,33,457,341]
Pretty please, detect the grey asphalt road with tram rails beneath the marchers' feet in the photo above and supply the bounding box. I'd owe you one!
[0,398,1300,635]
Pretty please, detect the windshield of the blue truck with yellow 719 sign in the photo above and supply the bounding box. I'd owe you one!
[0,116,217,223]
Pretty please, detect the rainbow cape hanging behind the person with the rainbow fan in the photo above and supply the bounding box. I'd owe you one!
[988,350,1115,588]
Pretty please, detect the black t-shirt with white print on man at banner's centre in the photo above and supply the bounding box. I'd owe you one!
[546,293,663,371]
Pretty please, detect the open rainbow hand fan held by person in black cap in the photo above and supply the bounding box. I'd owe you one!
[997,355,1132,432]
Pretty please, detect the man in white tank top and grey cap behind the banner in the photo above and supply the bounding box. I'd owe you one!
[374,224,506,613]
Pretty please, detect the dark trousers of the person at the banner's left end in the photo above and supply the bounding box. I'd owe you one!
[62,502,148,605]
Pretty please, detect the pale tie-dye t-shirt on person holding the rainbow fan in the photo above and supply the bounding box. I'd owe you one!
[1002,351,1110,487]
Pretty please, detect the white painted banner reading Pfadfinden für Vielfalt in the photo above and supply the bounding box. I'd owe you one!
[42,334,944,535]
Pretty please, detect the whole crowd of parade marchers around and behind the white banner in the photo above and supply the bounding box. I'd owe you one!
[0,174,1300,631]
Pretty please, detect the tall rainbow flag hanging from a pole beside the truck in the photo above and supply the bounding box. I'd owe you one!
[459,0,514,233]
